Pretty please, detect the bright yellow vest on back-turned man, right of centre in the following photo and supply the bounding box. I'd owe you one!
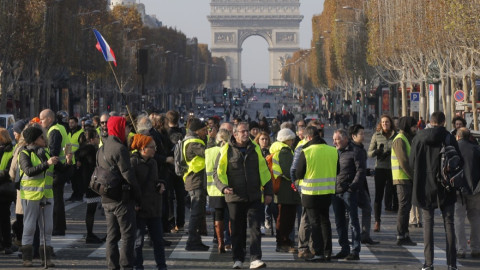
[299,144,338,195]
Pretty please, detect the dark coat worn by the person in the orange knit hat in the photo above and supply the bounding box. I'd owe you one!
[130,152,165,218]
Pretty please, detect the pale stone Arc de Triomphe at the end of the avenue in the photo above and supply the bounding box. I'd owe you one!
[208,0,303,88]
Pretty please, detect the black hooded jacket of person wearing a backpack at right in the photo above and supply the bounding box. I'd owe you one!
[409,126,459,210]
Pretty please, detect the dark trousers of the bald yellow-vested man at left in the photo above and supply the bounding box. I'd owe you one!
[52,171,67,234]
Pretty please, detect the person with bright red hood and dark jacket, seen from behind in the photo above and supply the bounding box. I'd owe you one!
[97,116,142,269]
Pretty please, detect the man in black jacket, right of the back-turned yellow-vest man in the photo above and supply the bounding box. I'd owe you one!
[332,129,367,260]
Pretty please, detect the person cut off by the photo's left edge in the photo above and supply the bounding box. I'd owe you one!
[0,128,16,254]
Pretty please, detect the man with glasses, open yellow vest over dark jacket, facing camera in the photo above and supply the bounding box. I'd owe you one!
[213,122,273,269]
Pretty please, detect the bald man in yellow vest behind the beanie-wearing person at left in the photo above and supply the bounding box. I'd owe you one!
[39,109,70,235]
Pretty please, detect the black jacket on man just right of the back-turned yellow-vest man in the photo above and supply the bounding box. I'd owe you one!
[335,142,367,194]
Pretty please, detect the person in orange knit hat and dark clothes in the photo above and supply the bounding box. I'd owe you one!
[130,134,167,269]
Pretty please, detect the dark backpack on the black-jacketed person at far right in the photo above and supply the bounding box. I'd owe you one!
[438,135,472,195]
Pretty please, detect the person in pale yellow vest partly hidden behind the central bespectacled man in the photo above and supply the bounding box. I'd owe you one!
[205,129,232,253]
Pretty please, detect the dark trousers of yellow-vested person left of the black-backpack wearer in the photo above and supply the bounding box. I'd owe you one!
[396,184,413,239]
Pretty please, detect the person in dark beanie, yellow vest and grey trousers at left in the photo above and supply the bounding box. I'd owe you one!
[19,127,72,267]
